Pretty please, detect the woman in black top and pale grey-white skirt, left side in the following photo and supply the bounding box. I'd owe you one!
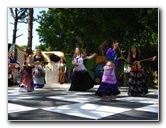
[33,49,45,88]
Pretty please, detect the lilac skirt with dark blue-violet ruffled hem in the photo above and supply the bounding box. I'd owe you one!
[95,66,120,96]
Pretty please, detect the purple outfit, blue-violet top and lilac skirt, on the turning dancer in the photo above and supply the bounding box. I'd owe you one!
[95,48,120,96]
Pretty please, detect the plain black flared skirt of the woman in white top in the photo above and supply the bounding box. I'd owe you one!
[69,70,94,91]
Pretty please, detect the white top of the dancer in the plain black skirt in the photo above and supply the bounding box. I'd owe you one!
[72,56,87,71]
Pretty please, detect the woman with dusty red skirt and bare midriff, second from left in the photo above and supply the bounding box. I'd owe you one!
[19,47,34,92]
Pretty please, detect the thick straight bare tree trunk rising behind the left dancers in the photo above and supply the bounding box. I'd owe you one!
[27,8,33,48]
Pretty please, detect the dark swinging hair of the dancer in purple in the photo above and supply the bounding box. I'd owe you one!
[99,39,114,55]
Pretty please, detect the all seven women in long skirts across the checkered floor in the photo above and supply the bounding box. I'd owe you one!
[8,39,156,101]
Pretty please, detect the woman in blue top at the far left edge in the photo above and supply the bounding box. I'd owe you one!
[8,52,20,84]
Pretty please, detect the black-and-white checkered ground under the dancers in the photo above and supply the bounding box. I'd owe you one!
[8,84,159,121]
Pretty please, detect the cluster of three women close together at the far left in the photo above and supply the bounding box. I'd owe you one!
[8,48,45,92]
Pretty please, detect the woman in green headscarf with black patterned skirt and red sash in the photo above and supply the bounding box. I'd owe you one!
[127,45,148,96]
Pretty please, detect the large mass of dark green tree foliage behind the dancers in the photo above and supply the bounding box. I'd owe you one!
[37,8,159,70]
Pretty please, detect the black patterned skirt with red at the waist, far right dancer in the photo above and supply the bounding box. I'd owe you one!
[128,68,148,96]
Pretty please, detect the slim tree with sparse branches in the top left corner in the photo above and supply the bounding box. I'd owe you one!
[9,8,27,44]
